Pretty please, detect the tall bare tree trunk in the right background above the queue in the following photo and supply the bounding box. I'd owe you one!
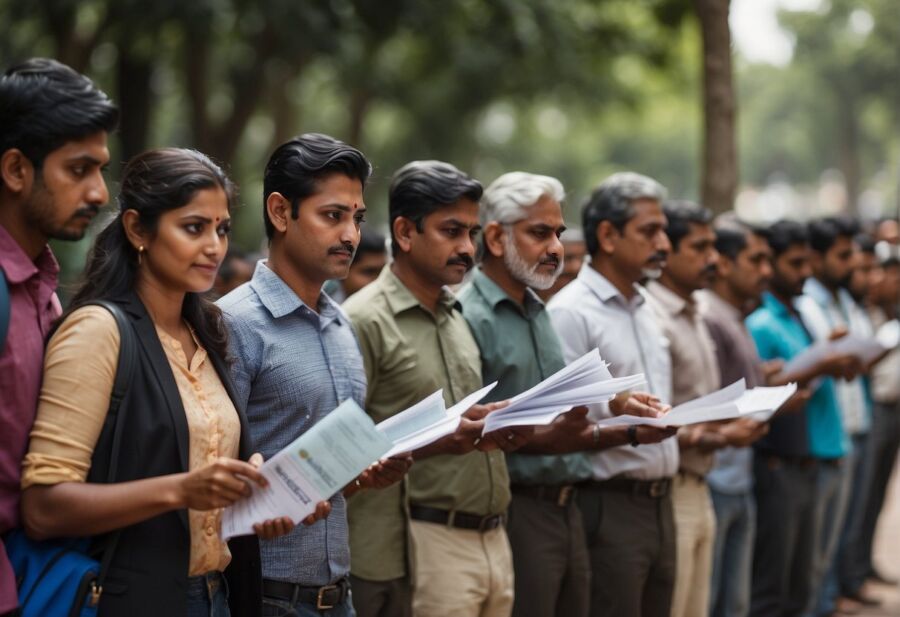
[694,0,738,212]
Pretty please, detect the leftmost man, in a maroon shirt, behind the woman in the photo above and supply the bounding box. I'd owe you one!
[0,58,118,616]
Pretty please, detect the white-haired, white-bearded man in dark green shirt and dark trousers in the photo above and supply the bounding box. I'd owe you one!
[459,172,668,617]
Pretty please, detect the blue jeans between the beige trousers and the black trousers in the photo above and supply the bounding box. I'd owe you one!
[709,490,756,617]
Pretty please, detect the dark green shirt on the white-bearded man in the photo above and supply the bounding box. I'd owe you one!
[459,268,591,486]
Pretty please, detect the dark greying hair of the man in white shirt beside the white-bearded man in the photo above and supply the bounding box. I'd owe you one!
[581,171,667,255]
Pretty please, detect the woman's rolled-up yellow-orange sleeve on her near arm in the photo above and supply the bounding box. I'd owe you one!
[22,306,119,489]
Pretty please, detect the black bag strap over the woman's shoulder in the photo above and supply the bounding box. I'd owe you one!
[91,300,137,590]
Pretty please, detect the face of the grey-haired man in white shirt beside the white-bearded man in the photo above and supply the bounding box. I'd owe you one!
[601,199,672,283]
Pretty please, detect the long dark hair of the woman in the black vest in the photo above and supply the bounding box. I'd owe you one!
[63,148,236,358]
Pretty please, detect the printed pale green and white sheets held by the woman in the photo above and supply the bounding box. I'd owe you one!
[222,400,391,540]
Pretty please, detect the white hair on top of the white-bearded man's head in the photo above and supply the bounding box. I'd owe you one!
[481,171,566,225]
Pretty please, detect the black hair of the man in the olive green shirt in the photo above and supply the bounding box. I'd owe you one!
[388,161,484,255]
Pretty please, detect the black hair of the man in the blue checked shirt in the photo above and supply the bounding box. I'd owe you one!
[263,133,372,240]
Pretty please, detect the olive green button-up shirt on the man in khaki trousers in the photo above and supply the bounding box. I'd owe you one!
[343,268,509,581]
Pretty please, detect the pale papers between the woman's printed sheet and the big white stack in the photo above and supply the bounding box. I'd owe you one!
[375,381,497,456]
